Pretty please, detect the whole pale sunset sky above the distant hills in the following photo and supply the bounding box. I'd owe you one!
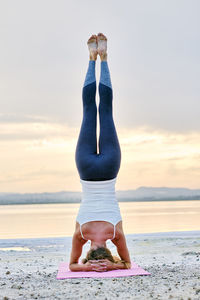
[0,0,200,193]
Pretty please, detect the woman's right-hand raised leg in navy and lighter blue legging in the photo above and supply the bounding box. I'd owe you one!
[98,36,121,179]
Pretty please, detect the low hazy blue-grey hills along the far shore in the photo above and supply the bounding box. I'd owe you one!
[0,187,200,205]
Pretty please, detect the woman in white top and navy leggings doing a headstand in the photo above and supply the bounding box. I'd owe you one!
[70,33,131,272]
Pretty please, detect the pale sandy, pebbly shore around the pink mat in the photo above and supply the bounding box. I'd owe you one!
[0,231,200,300]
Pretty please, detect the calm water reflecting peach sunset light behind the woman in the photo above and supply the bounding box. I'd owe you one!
[0,200,200,239]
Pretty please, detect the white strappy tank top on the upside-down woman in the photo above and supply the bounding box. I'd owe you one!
[76,178,122,238]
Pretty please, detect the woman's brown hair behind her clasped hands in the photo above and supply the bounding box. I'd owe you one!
[82,247,120,264]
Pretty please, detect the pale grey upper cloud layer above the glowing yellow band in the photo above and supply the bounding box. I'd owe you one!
[0,0,200,132]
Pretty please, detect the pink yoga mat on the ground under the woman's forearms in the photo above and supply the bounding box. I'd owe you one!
[56,261,151,279]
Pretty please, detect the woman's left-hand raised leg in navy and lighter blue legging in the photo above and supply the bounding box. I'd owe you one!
[75,37,97,180]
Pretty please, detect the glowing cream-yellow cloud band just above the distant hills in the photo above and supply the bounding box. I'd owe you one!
[0,118,200,192]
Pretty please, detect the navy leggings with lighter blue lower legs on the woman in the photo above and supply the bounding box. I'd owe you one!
[75,62,121,181]
